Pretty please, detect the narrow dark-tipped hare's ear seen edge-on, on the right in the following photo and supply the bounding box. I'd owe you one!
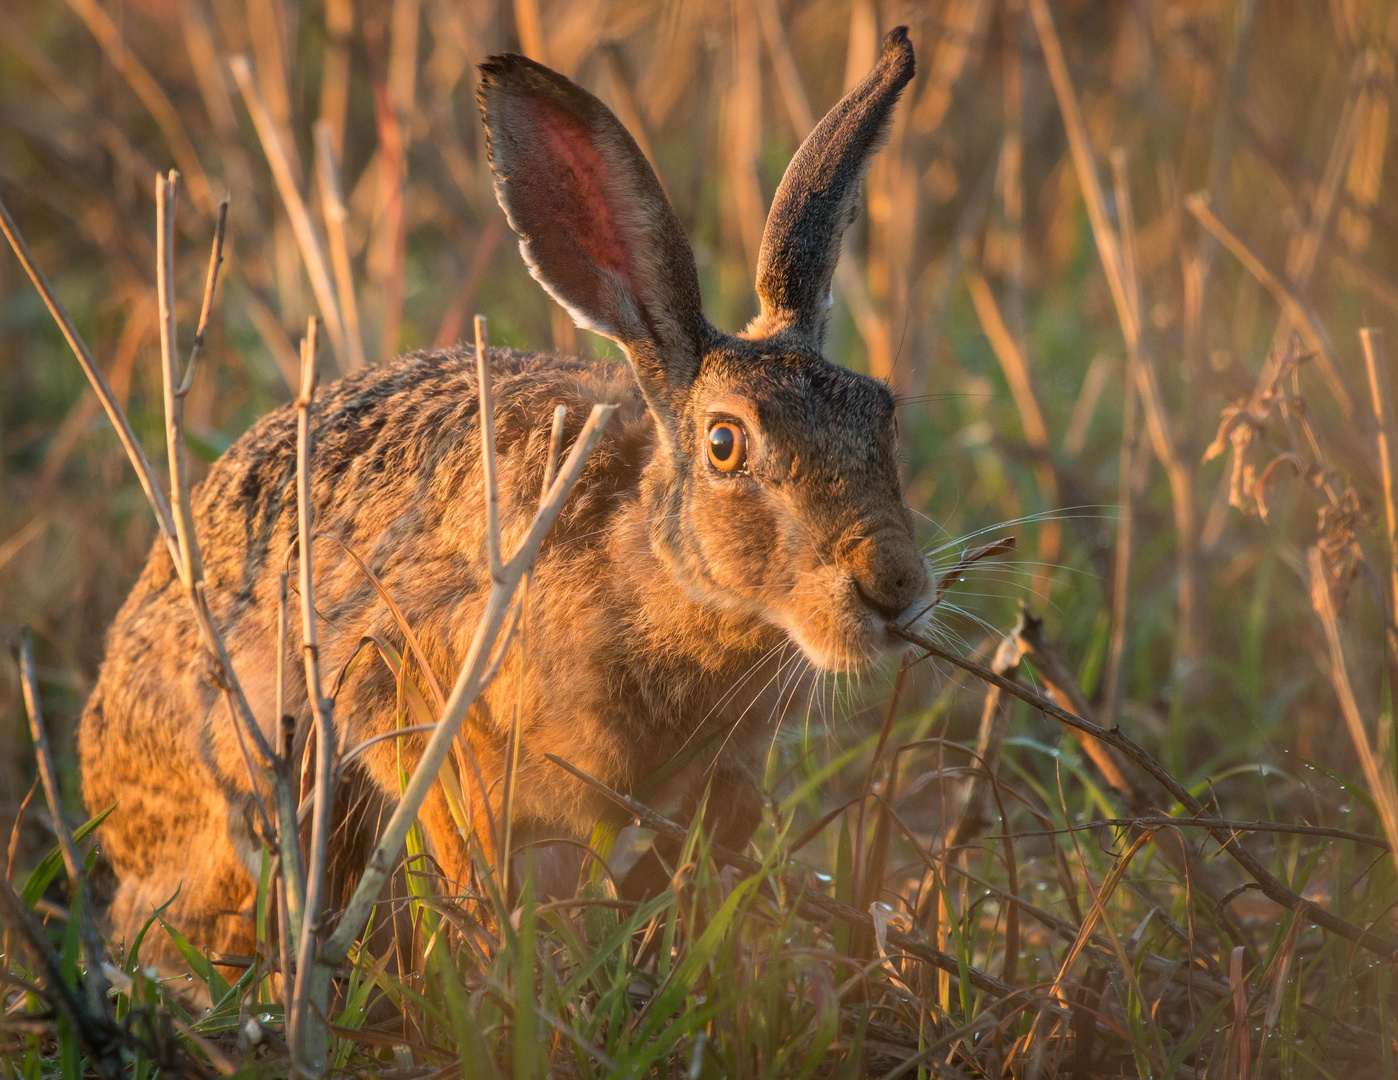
[747,27,913,349]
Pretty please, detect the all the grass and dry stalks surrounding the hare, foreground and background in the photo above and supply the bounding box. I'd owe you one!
[0,0,1398,1077]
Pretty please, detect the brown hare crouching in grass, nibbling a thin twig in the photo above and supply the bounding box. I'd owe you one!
[78,28,934,960]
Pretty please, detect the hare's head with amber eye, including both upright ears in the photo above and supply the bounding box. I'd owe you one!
[480,28,932,669]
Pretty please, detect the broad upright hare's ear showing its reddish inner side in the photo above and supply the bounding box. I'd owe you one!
[477,54,712,402]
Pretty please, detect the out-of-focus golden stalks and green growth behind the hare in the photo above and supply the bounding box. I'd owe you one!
[0,0,1398,1067]
